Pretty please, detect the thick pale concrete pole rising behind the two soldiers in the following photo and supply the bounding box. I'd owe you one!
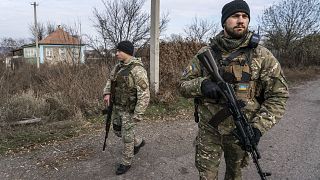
[150,0,160,94]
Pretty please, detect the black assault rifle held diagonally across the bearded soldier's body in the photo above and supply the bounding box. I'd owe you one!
[197,50,271,180]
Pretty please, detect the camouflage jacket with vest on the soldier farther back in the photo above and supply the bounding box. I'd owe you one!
[103,57,150,120]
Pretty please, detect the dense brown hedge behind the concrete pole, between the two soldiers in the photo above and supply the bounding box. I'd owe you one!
[138,40,203,103]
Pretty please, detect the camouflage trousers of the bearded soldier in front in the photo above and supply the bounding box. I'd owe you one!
[195,124,249,180]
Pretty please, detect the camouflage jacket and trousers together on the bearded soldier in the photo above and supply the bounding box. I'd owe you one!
[179,31,289,180]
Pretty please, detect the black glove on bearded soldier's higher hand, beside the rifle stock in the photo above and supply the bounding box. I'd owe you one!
[201,79,221,99]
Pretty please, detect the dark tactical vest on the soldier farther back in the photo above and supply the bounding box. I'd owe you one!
[115,62,142,113]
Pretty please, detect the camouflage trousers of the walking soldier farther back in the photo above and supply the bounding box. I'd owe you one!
[112,110,142,165]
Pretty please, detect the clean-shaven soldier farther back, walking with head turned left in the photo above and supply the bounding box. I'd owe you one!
[103,41,150,175]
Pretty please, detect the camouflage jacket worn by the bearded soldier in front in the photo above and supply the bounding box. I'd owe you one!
[179,42,289,134]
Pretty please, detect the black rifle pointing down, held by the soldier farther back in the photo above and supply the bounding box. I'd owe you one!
[102,80,116,151]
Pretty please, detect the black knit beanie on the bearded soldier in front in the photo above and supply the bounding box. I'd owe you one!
[221,0,250,27]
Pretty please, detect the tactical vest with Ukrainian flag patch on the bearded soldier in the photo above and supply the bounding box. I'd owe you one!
[194,34,261,124]
